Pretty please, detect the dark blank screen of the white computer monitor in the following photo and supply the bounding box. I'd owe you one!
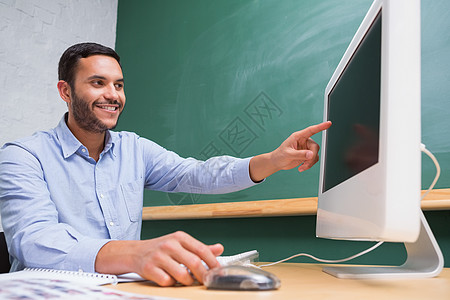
[322,12,381,192]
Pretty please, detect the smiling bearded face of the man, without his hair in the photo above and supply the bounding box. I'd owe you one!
[69,55,125,133]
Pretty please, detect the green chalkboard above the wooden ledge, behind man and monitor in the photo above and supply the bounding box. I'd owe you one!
[116,0,450,206]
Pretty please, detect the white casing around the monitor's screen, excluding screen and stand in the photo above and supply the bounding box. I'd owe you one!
[316,0,421,242]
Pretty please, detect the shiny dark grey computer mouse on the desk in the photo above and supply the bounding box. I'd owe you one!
[203,265,281,291]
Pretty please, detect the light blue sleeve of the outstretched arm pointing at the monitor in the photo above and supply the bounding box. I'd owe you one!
[139,138,255,194]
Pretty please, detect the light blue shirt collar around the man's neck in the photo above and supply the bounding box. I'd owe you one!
[55,113,116,158]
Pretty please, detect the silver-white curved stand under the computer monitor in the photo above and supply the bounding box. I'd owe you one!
[323,211,444,279]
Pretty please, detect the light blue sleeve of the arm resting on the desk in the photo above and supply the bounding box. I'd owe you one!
[0,145,109,272]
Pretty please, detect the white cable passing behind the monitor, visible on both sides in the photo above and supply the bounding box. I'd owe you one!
[253,144,441,268]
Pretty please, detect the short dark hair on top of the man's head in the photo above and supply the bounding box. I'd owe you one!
[58,43,122,89]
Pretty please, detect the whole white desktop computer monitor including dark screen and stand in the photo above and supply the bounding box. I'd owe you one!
[316,0,443,278]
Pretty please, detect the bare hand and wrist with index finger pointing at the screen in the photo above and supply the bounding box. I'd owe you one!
[249,121,331,182]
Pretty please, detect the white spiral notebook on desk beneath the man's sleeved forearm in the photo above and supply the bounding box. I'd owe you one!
[0,268,118,285]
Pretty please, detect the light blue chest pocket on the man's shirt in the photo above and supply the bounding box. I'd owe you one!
[120,180,144,222]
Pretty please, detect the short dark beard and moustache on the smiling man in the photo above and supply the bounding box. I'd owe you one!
[72,90,123,133]
